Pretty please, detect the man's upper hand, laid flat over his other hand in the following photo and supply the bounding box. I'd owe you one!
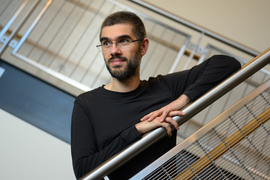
[141,94,190,123]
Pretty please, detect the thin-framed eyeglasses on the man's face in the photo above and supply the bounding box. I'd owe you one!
[96,39,143,52]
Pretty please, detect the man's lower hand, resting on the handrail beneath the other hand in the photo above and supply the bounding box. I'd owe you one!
[135,111,179,136]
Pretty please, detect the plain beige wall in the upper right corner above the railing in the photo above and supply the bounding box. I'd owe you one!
[141,0,270,52]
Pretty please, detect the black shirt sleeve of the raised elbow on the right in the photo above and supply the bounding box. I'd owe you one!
[160,55,241,101]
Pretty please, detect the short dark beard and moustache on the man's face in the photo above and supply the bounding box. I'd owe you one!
[105,53,141,82]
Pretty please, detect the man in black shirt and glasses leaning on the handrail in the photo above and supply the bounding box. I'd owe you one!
[71,11,240,180]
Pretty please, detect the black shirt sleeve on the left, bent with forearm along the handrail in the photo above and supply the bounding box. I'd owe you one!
[71,101,141,178]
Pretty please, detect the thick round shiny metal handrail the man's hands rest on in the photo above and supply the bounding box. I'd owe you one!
[81,48,270,180]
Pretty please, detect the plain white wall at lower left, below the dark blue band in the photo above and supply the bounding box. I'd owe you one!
[0,109,75,180]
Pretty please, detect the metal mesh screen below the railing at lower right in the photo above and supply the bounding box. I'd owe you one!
[141,88,270,180]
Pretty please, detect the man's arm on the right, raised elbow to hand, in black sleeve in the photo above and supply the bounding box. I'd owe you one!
[141,55,241,122]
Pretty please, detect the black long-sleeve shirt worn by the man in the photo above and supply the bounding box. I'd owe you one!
[71,55,241,180]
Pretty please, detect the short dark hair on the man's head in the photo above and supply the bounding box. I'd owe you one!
[99,11,146,39]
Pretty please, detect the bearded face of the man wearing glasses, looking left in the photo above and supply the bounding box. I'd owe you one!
[101,24,141,81]
